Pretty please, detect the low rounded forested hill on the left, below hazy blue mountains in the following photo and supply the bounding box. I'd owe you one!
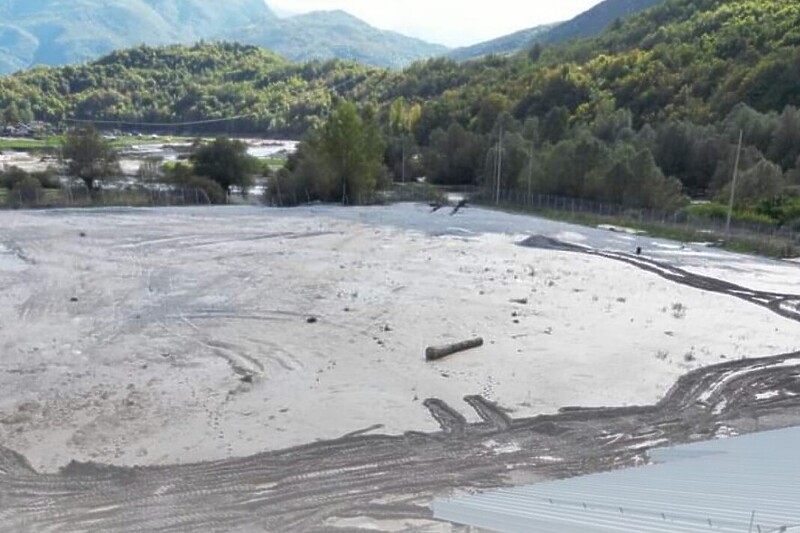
[0,44,383,135]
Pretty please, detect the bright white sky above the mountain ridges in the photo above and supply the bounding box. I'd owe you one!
[267,0,600,47]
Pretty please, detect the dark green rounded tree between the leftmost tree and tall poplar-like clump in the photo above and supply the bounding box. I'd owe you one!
[191,137,258,192]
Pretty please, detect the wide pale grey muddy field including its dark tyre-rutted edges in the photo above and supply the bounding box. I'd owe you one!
[0,206,800,531]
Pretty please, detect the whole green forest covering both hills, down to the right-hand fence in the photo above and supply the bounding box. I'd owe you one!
[0,0,800,218]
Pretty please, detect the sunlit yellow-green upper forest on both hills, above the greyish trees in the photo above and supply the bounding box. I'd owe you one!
[6,0,800,132]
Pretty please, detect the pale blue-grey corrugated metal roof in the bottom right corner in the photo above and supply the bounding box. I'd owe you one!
[433,428,800,533]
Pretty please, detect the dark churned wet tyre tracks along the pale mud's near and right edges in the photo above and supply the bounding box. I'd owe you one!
[0,238,800,532]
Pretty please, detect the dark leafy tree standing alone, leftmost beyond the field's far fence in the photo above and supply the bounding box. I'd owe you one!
[62,126,120,191]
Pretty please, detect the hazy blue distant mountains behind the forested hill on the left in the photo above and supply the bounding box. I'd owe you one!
[0,0,446,74]
